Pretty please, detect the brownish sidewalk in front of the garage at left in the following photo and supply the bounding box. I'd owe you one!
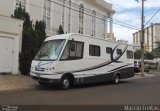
[0,74,37,91]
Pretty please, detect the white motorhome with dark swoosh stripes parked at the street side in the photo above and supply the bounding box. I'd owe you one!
[30,34,134,89]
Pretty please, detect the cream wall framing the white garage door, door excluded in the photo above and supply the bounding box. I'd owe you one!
[0,15,23,74]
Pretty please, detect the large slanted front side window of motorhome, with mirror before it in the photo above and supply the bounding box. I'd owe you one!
[61,41,84,60]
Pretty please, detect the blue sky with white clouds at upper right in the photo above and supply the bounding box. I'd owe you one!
[106,0,160,43]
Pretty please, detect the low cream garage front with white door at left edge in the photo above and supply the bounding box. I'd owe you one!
[0,15,23,74]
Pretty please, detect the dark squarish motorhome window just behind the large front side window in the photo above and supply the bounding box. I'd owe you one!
[89,45,100,56]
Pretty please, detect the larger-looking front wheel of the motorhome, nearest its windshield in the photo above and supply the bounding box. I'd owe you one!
[60,76,71,90]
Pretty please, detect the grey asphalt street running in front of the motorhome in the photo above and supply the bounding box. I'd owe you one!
[0,76,160,105]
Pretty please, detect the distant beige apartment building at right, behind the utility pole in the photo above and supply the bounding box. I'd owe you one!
[133,23,160,52]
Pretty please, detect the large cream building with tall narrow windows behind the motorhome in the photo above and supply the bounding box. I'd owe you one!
[0,0,115,40]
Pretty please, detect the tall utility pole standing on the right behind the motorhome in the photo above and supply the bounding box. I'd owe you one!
[141,0,145,77]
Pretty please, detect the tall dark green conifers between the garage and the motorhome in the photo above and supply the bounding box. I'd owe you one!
[12,4,46,75]
